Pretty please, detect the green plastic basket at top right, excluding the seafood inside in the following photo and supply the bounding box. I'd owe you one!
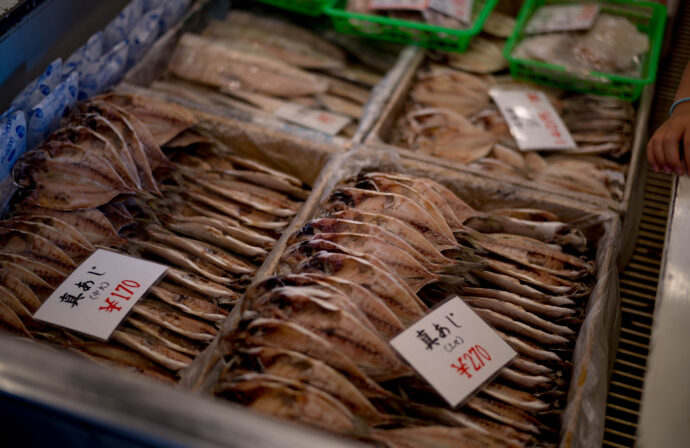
[503,0,666,101]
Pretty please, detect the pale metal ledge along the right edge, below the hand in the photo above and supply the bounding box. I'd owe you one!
[635,176,690,448]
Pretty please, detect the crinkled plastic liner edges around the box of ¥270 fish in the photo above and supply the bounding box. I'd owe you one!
[183,149,621,447]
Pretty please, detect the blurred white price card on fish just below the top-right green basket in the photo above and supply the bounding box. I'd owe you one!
[489,88,577,151]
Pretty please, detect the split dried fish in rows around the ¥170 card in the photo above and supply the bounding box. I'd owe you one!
[0,95,308,382]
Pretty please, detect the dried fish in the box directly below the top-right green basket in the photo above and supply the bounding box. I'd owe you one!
[392,56,634,200]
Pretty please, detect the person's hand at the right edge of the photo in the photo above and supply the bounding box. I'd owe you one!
[647,103,690,175]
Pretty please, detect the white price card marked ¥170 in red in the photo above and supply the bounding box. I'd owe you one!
[34,249,168,341]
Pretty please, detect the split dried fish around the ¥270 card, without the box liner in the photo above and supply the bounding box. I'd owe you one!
[215,172,595,448]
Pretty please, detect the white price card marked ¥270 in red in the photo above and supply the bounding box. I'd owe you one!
[391,296,517,407]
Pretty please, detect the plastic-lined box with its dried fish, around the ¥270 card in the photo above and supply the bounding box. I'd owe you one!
[187,150,620,446]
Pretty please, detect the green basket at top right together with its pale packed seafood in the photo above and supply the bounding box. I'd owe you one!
[505,0,666,101]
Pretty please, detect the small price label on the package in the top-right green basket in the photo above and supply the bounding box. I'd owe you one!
[525,3,599,34]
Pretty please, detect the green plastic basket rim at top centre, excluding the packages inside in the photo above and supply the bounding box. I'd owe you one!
[324,0,498,52]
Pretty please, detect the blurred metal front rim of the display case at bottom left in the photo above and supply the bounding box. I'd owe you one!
[0,336,366,448]
